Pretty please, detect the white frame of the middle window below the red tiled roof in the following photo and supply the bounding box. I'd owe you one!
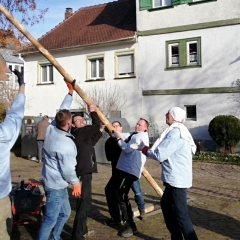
[87,54,105,80]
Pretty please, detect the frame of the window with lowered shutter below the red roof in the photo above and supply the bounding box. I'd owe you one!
[115,50,135,78]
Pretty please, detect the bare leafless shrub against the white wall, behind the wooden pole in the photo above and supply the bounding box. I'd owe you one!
[75,83,127,117]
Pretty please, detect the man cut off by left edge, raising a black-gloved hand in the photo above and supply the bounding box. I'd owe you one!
[0,70,25,240]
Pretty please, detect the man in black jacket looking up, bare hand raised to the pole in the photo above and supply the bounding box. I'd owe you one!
[71,104,103,240]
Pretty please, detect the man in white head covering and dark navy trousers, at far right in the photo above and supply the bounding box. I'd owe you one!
[131,107,198,240]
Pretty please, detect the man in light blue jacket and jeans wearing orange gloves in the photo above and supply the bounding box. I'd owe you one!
[38,83,81,240]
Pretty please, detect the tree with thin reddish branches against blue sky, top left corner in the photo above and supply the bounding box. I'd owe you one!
[0,0,48,46]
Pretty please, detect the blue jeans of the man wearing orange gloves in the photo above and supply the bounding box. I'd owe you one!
[38,186,71,240]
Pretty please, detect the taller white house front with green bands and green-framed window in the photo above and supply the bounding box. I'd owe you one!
[137,0,240,148]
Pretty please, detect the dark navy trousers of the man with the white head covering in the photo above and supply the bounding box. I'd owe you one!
[161,186,198,240]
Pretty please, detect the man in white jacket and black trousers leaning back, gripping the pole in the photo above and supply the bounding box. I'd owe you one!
[109,118,149,237]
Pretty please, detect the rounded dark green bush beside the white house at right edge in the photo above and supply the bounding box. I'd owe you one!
[208,115,240,154]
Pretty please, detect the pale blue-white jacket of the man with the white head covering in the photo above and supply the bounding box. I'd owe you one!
[146,127,192,188]
